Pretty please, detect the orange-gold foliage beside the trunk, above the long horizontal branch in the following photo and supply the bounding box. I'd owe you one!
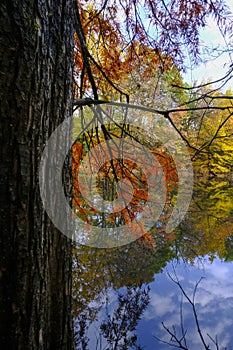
[74,5,173,97]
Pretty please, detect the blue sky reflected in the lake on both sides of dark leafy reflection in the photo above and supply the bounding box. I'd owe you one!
[84,259,233,350]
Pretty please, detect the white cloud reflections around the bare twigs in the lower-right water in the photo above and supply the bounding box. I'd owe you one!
[145,259,233,350]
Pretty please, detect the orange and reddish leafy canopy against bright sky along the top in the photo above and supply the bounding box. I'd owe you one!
[75,0,232,99]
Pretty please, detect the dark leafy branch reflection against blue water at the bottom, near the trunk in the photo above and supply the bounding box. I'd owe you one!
[76,286,149,350]
